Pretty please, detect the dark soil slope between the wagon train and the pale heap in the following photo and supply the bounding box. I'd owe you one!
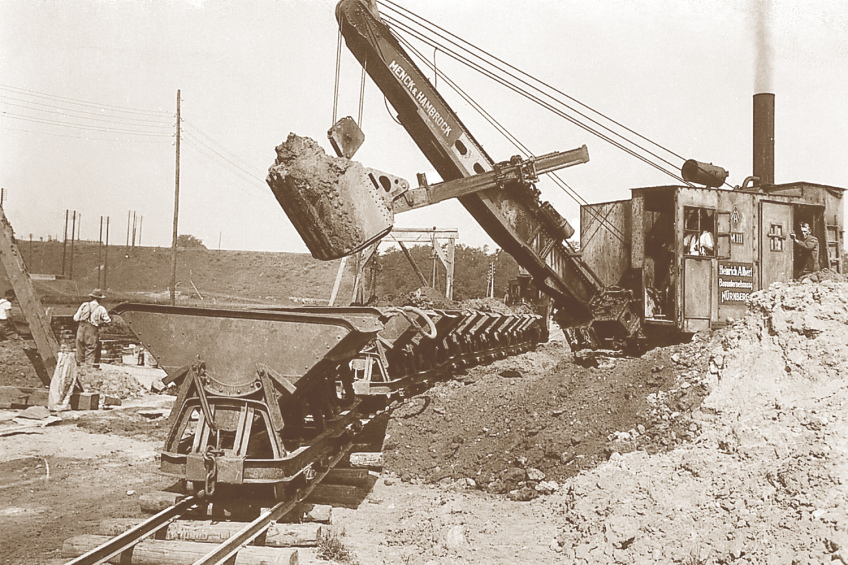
[385,339,709,490]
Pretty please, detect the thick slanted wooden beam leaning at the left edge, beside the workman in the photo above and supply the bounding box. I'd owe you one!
[0,207,59,386]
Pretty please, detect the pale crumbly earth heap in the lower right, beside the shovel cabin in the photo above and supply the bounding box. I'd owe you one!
[552,281,848,564]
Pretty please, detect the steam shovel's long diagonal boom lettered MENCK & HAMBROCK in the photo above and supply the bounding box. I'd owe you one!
[336,0,640,347]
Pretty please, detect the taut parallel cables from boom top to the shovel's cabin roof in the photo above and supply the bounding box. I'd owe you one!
[383,0,689,184]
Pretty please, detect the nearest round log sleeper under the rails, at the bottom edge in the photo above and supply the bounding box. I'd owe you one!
[62,535,298,565]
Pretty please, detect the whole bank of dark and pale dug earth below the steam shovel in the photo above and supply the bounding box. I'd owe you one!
[385,280,848,565]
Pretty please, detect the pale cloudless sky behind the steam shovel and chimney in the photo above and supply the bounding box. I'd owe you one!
[0,0,848,252]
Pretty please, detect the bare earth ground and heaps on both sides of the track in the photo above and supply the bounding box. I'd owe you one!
[0,280,848,565]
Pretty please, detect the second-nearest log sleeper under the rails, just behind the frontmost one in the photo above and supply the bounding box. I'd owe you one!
[100,518,325,547]
